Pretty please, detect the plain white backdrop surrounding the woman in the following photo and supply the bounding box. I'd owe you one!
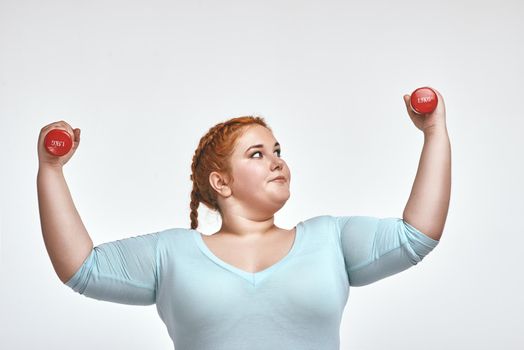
[0,0,524,350]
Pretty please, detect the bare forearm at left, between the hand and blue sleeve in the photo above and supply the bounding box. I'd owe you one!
[37,167,93,283]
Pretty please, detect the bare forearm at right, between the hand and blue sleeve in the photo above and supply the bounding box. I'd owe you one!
[403,128,451,240]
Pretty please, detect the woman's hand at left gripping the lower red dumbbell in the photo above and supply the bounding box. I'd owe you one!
[38,120,80,167]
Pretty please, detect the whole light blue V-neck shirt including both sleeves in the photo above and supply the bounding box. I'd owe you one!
[66,215,439,350]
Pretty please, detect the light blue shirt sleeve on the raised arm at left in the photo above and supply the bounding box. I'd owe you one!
[65,233,159,305]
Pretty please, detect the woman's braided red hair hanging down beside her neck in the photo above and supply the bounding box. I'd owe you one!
[189,116,271,229]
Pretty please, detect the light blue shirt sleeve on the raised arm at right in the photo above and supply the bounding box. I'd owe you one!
[335,216,439,286]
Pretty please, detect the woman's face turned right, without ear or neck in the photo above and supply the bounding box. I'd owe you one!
[224,124,291,215]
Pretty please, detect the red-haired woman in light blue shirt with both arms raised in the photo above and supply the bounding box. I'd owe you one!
[37,89,451,350]
